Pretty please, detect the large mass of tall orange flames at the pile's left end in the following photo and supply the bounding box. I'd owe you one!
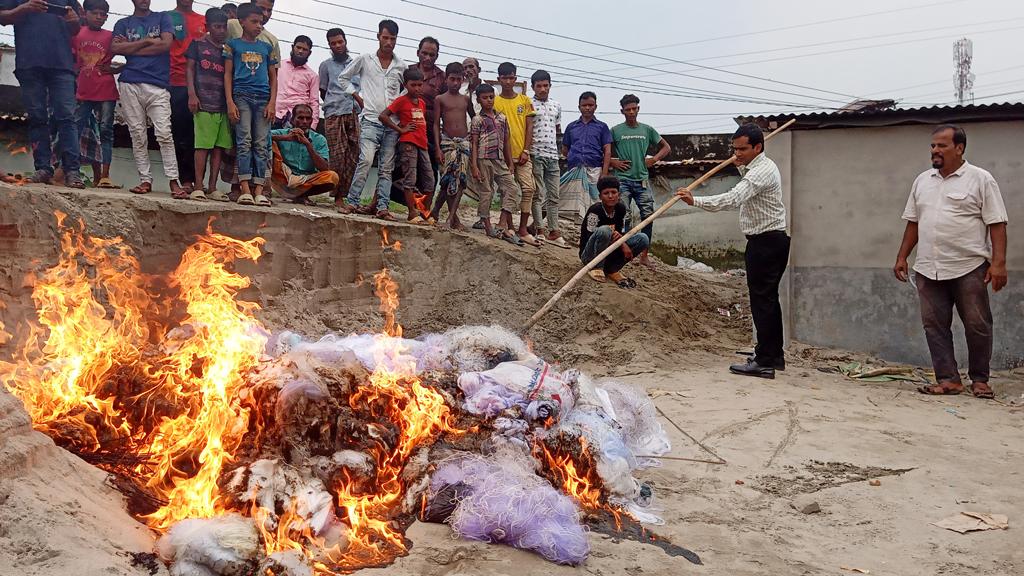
[0,213,265,529]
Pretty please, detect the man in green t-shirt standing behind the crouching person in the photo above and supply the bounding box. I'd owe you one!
[611,94,672,268]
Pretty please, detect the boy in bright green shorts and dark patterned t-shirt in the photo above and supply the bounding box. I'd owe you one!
[185,8,233,202]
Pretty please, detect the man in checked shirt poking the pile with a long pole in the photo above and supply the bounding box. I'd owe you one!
[676,124,790,378]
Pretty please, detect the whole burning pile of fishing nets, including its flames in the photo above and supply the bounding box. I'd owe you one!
[0,215,670,576]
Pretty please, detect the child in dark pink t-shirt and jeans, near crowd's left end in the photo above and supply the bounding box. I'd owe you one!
[72,0,121,188]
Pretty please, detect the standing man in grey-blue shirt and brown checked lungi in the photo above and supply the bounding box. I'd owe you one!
[319,28,359,208]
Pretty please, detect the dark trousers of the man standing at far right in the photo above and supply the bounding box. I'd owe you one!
[913,262,992,384]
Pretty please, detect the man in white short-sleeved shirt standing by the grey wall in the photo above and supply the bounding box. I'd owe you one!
[893,125,1008,398]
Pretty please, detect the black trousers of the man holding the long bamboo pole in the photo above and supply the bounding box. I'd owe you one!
[744,230,790,366]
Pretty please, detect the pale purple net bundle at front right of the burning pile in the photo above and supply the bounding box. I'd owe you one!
[428,453,590,566]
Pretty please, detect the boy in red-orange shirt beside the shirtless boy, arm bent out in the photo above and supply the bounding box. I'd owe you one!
[380,67,434,224]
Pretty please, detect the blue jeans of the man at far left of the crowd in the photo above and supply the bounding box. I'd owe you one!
[14,68,80,174]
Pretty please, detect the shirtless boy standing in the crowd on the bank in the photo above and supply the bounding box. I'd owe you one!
[430,63,475,226]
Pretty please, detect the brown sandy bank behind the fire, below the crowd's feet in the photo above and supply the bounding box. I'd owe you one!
[0,181,751,367]
